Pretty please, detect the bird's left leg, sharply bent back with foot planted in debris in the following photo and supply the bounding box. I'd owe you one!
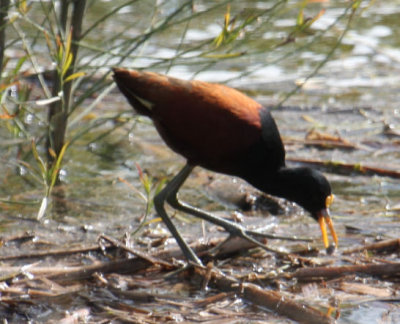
[154,164,202,265]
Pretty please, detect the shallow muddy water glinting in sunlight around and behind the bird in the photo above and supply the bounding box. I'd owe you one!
[0,1,400,323]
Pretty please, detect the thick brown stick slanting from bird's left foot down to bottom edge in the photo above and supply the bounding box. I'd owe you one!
[196,268,334,324]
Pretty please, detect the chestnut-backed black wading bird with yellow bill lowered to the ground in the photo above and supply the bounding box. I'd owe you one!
[113,67,338,265]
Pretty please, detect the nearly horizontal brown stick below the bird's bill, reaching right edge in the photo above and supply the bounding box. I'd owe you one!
[285,263,400,280]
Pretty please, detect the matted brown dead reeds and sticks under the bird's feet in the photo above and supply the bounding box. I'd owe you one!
[0,230,400,323]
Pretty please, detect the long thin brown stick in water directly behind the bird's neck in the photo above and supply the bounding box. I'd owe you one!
[286,158,400,179]
